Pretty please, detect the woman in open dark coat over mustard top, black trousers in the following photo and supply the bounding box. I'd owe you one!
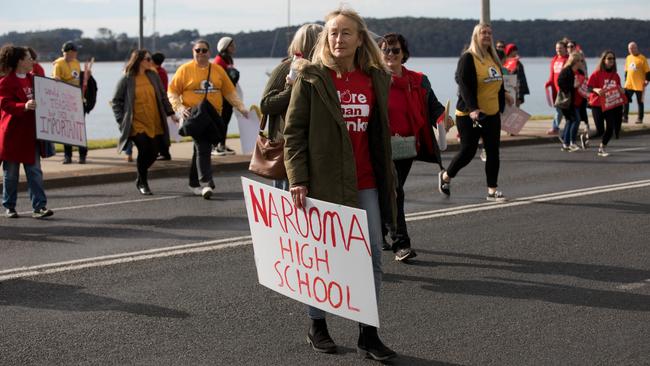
[112,50,177,195]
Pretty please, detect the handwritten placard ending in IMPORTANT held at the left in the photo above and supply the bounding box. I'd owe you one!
[34,76,87,146]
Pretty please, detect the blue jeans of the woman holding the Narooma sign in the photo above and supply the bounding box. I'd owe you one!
[308,188,383,319]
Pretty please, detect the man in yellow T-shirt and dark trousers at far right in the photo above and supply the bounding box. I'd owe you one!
[623,42,650,124]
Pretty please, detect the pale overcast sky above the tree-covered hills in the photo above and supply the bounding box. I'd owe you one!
[0,0,650,38]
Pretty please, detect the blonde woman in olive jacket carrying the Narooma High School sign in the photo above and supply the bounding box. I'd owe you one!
[284,8,395,360]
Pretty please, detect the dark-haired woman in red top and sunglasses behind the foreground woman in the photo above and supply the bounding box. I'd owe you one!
[379,33,445,261]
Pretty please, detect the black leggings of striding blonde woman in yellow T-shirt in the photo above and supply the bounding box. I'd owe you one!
[447,113,501,188]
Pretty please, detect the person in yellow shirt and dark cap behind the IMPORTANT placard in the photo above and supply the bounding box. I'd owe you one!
[52,41,88,164]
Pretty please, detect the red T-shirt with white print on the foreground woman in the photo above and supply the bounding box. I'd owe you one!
[330,70,376,189]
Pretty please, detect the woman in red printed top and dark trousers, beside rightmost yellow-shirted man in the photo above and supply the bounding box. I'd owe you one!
[587,50,625,157]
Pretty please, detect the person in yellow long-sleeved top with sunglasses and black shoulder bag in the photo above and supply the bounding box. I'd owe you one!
[167,39,248,199]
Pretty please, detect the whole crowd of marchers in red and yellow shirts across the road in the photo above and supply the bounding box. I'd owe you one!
[0,8,650,360]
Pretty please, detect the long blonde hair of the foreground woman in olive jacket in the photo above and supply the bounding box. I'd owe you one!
[312,7,388,74]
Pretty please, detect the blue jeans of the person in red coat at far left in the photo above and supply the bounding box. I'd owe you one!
[2,144,47,210]
